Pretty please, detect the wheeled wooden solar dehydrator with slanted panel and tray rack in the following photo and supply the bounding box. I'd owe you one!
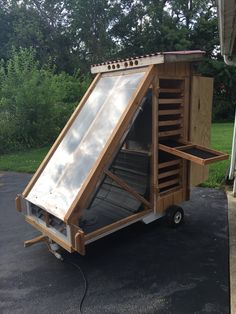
[16,51,228,255]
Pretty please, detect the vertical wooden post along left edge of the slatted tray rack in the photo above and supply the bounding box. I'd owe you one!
[150,69,159,212]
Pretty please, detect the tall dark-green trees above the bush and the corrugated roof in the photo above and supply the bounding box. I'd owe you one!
[0,0,219,68]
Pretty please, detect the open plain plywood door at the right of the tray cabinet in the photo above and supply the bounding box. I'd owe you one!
[189,76,213,186]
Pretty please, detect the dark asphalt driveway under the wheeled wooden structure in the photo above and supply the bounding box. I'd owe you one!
[0,172,229,314]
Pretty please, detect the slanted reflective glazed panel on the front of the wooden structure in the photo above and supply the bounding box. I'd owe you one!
[26,70,145,219]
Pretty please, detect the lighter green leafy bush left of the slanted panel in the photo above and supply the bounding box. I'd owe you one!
[0,48,90,153]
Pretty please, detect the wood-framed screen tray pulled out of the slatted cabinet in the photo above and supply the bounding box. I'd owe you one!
[159,140,228,165]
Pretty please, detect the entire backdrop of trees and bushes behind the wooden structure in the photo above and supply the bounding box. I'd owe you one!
[0,0,236,151]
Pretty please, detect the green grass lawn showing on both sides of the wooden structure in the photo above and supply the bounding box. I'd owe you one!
[0,123,233,187]
